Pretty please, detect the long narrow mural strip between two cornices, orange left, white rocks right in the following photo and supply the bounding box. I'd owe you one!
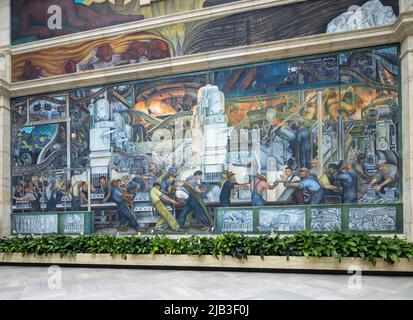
[12,0,398,82]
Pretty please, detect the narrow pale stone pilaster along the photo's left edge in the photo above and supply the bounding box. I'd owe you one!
[0,0,11,236]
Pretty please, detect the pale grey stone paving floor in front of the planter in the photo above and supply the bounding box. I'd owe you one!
[0,266,413,300]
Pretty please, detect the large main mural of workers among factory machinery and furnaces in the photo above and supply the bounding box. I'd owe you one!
[12,47,401,233]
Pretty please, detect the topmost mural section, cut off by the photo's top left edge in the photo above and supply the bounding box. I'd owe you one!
[11,0,239,44]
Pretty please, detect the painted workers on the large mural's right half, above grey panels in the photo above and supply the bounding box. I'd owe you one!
[219,160,399,207]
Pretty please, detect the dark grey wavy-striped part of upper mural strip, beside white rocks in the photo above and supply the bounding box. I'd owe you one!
[187,0,399,54]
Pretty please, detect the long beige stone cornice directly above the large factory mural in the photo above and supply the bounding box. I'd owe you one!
[10,12,413,97]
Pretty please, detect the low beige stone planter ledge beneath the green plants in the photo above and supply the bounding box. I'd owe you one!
[0,253,413,272]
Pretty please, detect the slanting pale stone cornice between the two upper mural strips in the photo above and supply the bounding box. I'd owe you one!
[11,0,307,54]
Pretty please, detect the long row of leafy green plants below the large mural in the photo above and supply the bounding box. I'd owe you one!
[0,231,413,264]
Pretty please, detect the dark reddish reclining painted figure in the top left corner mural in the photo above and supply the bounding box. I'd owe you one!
[19,0,143,39]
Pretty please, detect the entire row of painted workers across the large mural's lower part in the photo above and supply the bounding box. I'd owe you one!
[13,156,399,232]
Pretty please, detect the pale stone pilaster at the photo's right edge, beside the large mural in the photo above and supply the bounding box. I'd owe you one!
[401,35,413,241]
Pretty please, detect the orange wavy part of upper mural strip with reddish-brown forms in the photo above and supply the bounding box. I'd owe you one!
[12,32,173,82]
